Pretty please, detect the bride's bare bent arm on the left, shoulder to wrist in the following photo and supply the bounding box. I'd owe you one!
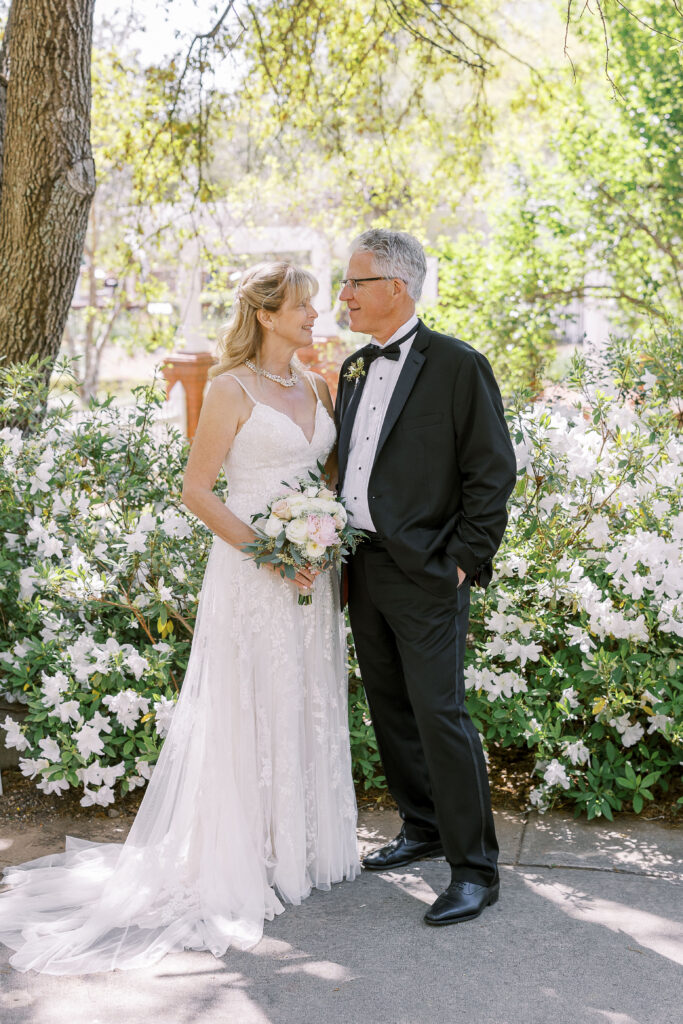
[182,376,256,548]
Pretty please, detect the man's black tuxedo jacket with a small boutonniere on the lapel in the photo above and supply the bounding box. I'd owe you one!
[335,322,516,597]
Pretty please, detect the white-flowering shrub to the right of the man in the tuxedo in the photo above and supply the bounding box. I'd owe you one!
[466,333,683,818]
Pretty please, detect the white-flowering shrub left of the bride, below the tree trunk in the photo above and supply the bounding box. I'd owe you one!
[0,365,211,806]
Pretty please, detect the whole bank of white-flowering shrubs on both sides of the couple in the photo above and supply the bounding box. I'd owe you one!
[0,337,683,817]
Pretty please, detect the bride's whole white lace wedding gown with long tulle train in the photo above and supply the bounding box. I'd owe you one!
[0,374,359,974]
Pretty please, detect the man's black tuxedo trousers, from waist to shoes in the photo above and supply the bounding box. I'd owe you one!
[348,543,498,885]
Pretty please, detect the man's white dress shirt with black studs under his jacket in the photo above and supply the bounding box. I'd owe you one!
[342,314,418,532]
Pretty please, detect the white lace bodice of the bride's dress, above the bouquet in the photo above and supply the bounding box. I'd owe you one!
[223,378,336,522]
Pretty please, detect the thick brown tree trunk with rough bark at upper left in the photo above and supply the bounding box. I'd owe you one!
[0,0,95,361]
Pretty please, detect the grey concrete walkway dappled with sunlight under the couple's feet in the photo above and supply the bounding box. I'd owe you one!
[0,810,683,1024]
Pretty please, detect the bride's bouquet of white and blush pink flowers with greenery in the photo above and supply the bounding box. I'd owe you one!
[242,462,366,604]
